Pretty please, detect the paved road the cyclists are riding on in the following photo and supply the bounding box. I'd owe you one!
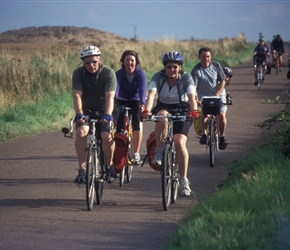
[0,57,289,249]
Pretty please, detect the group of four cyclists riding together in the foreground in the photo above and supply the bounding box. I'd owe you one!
[72,45,233,196]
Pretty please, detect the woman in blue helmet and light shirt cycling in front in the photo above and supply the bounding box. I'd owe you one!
[142,51,198,196]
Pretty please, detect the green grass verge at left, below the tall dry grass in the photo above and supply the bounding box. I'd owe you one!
[0,93,73,142]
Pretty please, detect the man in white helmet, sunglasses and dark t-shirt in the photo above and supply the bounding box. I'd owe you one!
[72,45,116,183]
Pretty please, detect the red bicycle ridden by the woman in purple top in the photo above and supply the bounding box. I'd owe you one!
[120,106,134,187]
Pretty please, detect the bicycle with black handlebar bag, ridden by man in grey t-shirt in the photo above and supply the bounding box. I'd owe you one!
[202,94,232,167]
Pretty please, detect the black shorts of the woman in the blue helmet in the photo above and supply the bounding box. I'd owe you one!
[152,101,193,136]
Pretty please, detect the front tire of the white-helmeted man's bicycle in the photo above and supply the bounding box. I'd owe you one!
[86,144,97,211]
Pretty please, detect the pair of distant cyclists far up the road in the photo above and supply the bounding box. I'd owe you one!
[253,34,285,86]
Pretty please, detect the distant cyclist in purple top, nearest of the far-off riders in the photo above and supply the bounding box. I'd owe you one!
[253,37,270,86]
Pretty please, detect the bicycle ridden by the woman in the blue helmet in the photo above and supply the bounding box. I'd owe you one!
[150,114,186,211]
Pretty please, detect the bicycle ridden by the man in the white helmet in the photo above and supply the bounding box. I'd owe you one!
[62,111,106,211]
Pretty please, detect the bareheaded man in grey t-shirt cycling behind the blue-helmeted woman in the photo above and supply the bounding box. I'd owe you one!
[191,47,227,150]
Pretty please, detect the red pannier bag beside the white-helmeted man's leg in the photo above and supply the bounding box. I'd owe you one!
[113,133,129,174]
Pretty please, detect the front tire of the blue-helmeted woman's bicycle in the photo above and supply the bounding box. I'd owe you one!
[161,143,172,211]
